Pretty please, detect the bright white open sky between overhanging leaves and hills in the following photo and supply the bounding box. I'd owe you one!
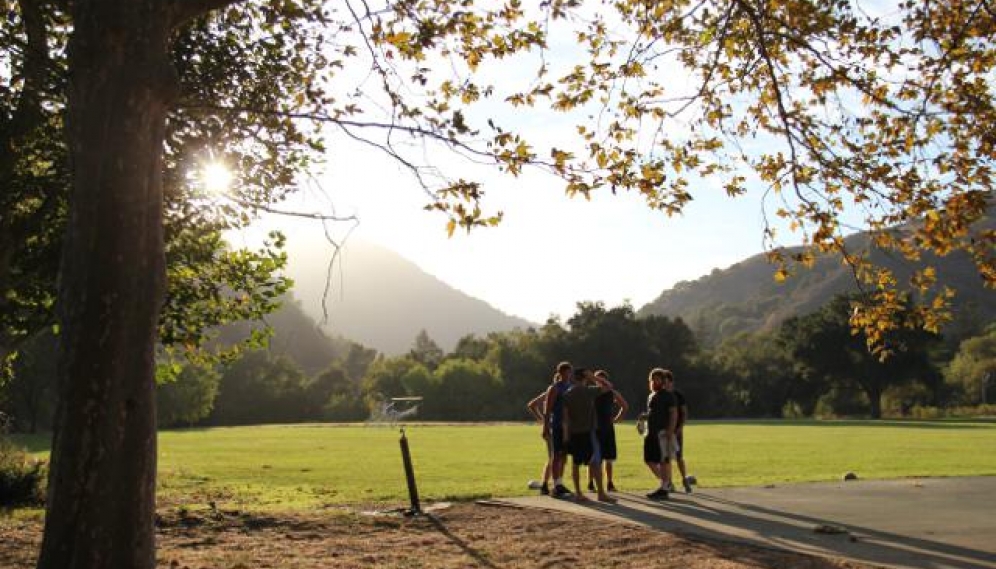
[226,2,904,323]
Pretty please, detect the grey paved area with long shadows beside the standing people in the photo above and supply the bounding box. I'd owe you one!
[502,477,996,569]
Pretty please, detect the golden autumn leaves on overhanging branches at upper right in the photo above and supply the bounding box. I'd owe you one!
[358,0,996,350]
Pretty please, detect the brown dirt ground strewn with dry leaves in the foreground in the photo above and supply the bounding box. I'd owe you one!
[0,503,868,569]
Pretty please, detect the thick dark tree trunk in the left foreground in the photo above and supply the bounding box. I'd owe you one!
[38,0,176,569]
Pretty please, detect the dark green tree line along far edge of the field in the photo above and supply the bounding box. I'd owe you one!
[0,296,996,431]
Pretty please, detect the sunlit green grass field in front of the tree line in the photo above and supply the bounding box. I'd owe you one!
[9,420,996,510]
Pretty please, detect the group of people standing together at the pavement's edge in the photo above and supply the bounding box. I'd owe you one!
[527,362,692,503]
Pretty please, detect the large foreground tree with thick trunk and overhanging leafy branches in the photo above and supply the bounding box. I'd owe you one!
[9,0,996,568]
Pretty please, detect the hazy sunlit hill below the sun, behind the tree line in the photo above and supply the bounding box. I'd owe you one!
[288,237,533,354]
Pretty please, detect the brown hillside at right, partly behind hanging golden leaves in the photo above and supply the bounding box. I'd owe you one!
[639,215,996,345]
